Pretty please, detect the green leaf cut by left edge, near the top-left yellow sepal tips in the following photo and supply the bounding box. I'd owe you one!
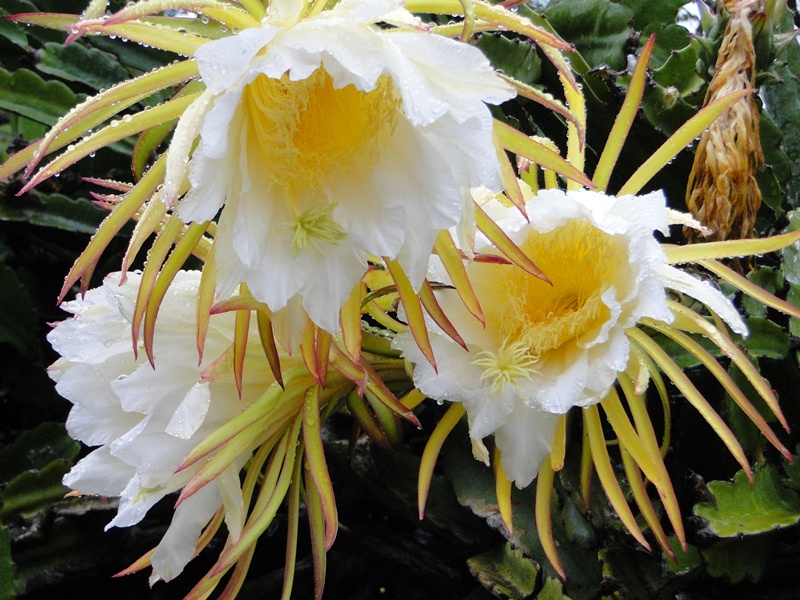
[0,68,80,125]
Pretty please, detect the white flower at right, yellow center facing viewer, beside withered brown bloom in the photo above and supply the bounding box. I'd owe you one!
[396,190,746,487]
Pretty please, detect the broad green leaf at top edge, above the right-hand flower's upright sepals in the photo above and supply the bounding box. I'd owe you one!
[545,0,634,71]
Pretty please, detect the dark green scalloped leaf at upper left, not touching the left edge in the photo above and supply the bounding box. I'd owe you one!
[36,42,128,90]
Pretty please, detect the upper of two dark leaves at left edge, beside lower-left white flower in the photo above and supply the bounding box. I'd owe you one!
[0,423,80,483]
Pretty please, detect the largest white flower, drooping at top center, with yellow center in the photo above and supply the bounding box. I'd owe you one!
[170,0,514,340]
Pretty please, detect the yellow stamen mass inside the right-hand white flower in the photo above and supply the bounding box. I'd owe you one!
[495,221,628,356]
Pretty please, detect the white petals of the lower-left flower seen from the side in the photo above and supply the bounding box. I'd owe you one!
[48,271,288,581]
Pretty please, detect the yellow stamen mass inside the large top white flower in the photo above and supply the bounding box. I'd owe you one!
[242,68,399,199]
